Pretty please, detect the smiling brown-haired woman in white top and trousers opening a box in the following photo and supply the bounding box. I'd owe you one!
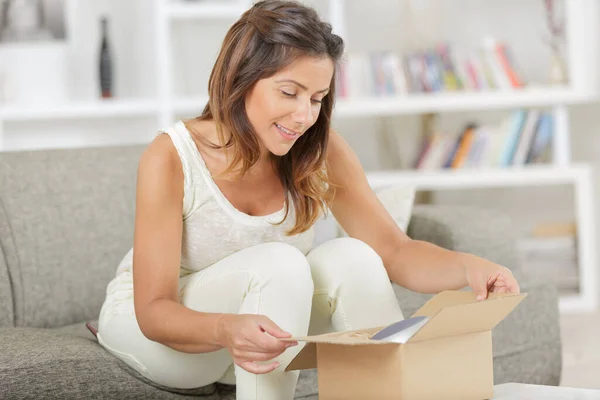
[98,1,519,400]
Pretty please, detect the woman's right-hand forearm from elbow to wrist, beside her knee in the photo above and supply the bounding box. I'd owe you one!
[386,240,475,293]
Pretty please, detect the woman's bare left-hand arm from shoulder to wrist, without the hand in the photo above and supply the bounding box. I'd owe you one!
[133,135,222,353]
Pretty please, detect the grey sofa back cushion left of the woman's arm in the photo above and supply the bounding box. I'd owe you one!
[0,146,143,327]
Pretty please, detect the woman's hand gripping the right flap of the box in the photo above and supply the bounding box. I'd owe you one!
[465,255,521,300]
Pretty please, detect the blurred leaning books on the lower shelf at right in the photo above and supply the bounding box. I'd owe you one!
[414,109,554,170]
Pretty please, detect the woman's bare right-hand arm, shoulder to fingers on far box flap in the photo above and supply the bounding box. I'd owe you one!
[327,131,519,298]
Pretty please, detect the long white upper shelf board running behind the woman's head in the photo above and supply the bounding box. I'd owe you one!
[0,88,590,122]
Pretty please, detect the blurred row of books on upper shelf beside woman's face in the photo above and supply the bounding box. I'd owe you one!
[336,37,526,99]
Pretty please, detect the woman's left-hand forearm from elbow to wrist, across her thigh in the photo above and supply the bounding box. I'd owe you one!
[137,299,225,353]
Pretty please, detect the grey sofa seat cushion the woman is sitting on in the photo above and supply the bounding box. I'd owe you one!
[0,322,317,400]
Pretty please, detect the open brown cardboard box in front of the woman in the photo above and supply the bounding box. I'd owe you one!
[286,291,526,400]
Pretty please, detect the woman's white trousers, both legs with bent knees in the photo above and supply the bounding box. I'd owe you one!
[98,238,403,400]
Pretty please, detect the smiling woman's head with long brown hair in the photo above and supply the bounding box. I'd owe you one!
[190,2,343,234]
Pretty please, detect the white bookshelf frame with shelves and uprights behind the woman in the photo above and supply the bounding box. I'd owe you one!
[0,0,598,311]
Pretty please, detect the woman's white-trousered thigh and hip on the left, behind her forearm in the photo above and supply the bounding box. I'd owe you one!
[98,243,313,388]
